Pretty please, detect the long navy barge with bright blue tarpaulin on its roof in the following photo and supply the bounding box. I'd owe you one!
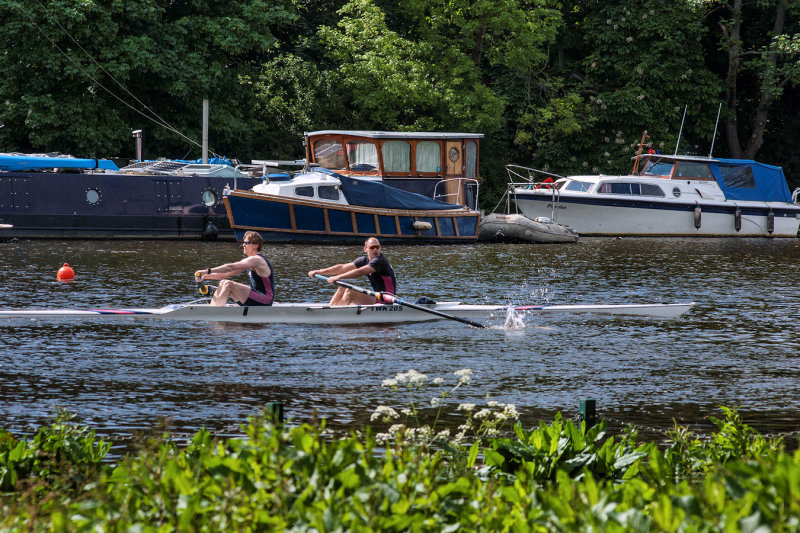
[0,153,261,240]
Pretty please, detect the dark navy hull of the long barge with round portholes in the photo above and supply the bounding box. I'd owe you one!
[0,172,261,240]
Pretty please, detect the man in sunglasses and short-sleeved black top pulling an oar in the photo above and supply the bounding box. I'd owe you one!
[308,237,397,306]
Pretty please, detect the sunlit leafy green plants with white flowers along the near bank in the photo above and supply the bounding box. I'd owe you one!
[0,371,800,531]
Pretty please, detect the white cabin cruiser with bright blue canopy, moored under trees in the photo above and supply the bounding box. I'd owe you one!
[506,153,800,237]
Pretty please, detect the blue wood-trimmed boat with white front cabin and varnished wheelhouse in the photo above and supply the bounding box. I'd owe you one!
[224,130,483,242]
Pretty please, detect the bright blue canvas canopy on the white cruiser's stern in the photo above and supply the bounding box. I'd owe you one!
[709,159,792,203]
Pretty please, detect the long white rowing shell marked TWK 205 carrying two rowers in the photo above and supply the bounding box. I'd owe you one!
[0,302,694,325]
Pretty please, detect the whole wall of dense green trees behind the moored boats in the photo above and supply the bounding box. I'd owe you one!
[0,0,800,201]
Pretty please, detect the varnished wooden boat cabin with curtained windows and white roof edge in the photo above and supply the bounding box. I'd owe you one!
[305,130,483,209]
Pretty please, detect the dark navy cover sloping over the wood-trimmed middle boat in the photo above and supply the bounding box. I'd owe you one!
[315,167,461,211]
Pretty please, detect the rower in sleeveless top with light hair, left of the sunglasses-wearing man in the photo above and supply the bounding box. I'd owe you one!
[194,231,275,306]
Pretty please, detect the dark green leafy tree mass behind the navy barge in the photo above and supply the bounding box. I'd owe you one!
[0,0,294,157]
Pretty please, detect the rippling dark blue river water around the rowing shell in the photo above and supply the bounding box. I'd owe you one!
[0,239,800,442]
